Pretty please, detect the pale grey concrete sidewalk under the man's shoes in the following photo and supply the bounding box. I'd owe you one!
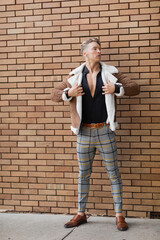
[0,213,160,240]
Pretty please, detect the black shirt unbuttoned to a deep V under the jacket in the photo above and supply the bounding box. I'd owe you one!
[82,65,119,124]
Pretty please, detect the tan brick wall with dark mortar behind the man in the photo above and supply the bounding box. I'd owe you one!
[0,0,160,217]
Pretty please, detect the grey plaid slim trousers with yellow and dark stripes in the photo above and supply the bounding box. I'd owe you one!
[77,124,122,213]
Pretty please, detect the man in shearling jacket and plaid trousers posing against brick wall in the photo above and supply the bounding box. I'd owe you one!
[51,38,139,231]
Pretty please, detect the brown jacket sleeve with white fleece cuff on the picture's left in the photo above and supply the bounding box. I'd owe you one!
[50,76,72,102]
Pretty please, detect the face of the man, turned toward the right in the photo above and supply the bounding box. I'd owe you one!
[83,42,101,62]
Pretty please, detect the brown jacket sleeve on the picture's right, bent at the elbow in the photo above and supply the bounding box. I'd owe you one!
[114,72,140,96]
